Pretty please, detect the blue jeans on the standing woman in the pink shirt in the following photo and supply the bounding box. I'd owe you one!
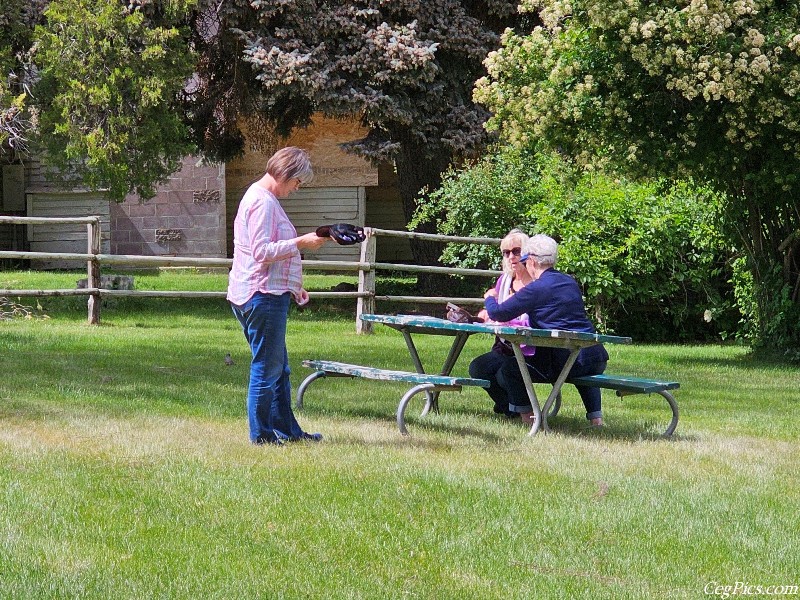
[231,292,303,444]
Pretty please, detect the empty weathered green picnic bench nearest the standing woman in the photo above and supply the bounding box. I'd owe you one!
[295,360,489,435]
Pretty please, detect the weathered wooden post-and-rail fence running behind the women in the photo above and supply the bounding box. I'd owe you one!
[0,216,501,333]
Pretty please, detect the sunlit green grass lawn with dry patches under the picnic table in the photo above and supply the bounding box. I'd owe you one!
[0,272,800,600]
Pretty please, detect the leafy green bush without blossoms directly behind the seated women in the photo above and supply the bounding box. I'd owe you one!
[415,148,738,341]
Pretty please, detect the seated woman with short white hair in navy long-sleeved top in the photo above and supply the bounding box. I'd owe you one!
[484,234,608,425]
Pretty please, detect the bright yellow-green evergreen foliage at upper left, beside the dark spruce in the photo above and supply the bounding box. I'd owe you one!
[34,0,194,200]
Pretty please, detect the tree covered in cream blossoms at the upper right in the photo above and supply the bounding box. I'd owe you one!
[475,0,800,356]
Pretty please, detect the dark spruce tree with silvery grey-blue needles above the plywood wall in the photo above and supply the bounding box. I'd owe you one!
[190,0,517,268]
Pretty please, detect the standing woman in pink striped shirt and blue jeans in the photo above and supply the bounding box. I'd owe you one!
[227,147,330,444]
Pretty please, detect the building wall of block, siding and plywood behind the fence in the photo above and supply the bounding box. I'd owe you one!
[12,117,411,262]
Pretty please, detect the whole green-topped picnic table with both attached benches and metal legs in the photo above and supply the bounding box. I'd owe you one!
[296,314,680,437]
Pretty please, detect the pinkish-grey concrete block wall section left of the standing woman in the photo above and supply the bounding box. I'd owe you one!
[111,157,227,258]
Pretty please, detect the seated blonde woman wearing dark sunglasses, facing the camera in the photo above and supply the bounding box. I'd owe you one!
[469,229,536,417]
